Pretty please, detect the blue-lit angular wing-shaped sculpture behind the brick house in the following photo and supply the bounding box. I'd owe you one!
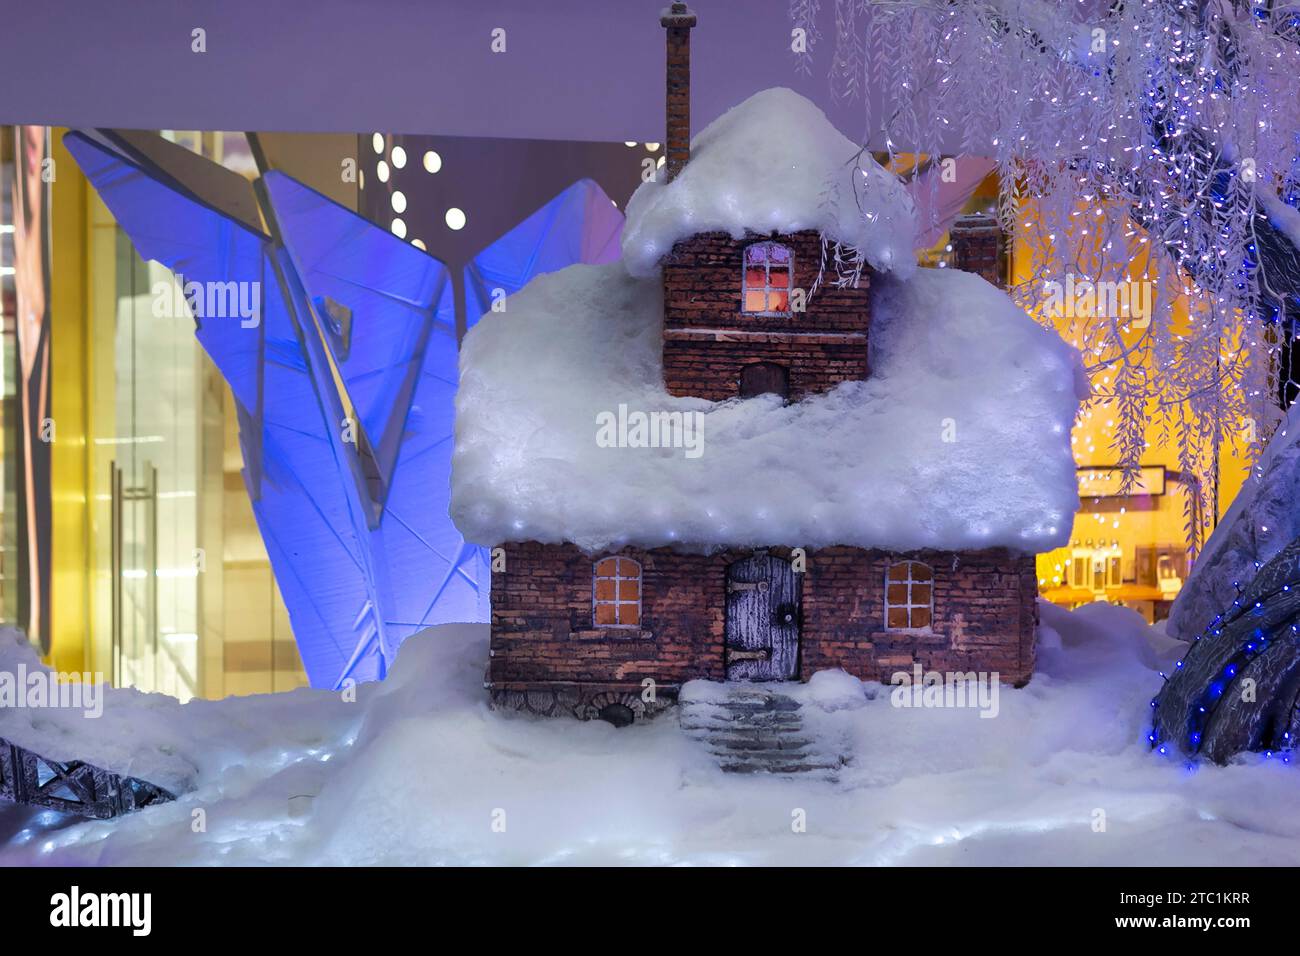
[64,133,623,688]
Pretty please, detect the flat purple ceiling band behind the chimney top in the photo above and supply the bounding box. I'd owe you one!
[0,0,904,142]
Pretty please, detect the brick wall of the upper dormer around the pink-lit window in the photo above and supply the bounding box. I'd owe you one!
[663,230,871,401]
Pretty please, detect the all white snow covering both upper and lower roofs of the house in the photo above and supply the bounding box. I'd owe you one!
[451,90,1087,553]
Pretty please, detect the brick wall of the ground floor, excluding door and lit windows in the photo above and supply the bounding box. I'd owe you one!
[489,542,1037,688]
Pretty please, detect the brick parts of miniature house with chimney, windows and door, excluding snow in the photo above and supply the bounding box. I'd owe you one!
[488,4,1037,723]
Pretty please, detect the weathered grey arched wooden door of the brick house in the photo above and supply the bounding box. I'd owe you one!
[725,551,802,680]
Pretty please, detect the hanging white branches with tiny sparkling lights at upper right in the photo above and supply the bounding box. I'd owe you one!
[792,0,1300,554]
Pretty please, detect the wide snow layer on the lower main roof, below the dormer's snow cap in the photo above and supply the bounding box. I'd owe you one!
[451,263,1086,551]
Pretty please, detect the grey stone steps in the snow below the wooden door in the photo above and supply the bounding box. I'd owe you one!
[677,684,846,779]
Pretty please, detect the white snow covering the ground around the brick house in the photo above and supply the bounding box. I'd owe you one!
[0,606,1300,865]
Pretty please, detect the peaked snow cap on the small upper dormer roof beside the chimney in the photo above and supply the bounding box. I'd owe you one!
[623,88,917,282]
